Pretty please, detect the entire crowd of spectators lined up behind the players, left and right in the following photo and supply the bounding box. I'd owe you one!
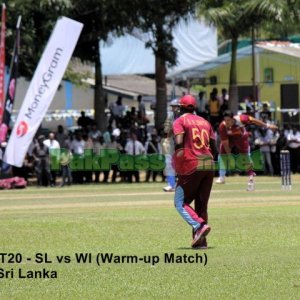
[3,89,300,186]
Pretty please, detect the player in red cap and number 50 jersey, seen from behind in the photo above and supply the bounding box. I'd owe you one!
[173,95,216,248]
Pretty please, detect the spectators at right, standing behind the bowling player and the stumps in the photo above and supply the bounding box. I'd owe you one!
[197,88,300,176]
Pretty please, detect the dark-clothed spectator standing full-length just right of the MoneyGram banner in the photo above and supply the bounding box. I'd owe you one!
[32,135,53,186]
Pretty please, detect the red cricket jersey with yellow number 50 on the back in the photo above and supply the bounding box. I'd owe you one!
[173,113,215,174]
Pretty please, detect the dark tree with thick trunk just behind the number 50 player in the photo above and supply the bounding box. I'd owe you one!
[133,0,195,130]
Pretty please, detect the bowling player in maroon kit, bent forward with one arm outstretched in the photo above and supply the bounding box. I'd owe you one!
[216,111,277,191]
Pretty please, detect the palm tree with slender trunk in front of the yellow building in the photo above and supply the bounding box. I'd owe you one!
[198,0,294,112]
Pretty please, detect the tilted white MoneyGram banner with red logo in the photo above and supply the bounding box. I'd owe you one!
[3,17,83,167]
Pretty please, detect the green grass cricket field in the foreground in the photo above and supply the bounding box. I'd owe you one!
[0,176,300,300]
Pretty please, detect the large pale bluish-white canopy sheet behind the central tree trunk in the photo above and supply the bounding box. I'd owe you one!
[100,18,217,76]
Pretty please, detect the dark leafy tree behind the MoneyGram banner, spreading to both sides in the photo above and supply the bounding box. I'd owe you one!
[7,0,133,130]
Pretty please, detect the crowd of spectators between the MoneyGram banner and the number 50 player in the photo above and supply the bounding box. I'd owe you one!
[9,96,164,186]
